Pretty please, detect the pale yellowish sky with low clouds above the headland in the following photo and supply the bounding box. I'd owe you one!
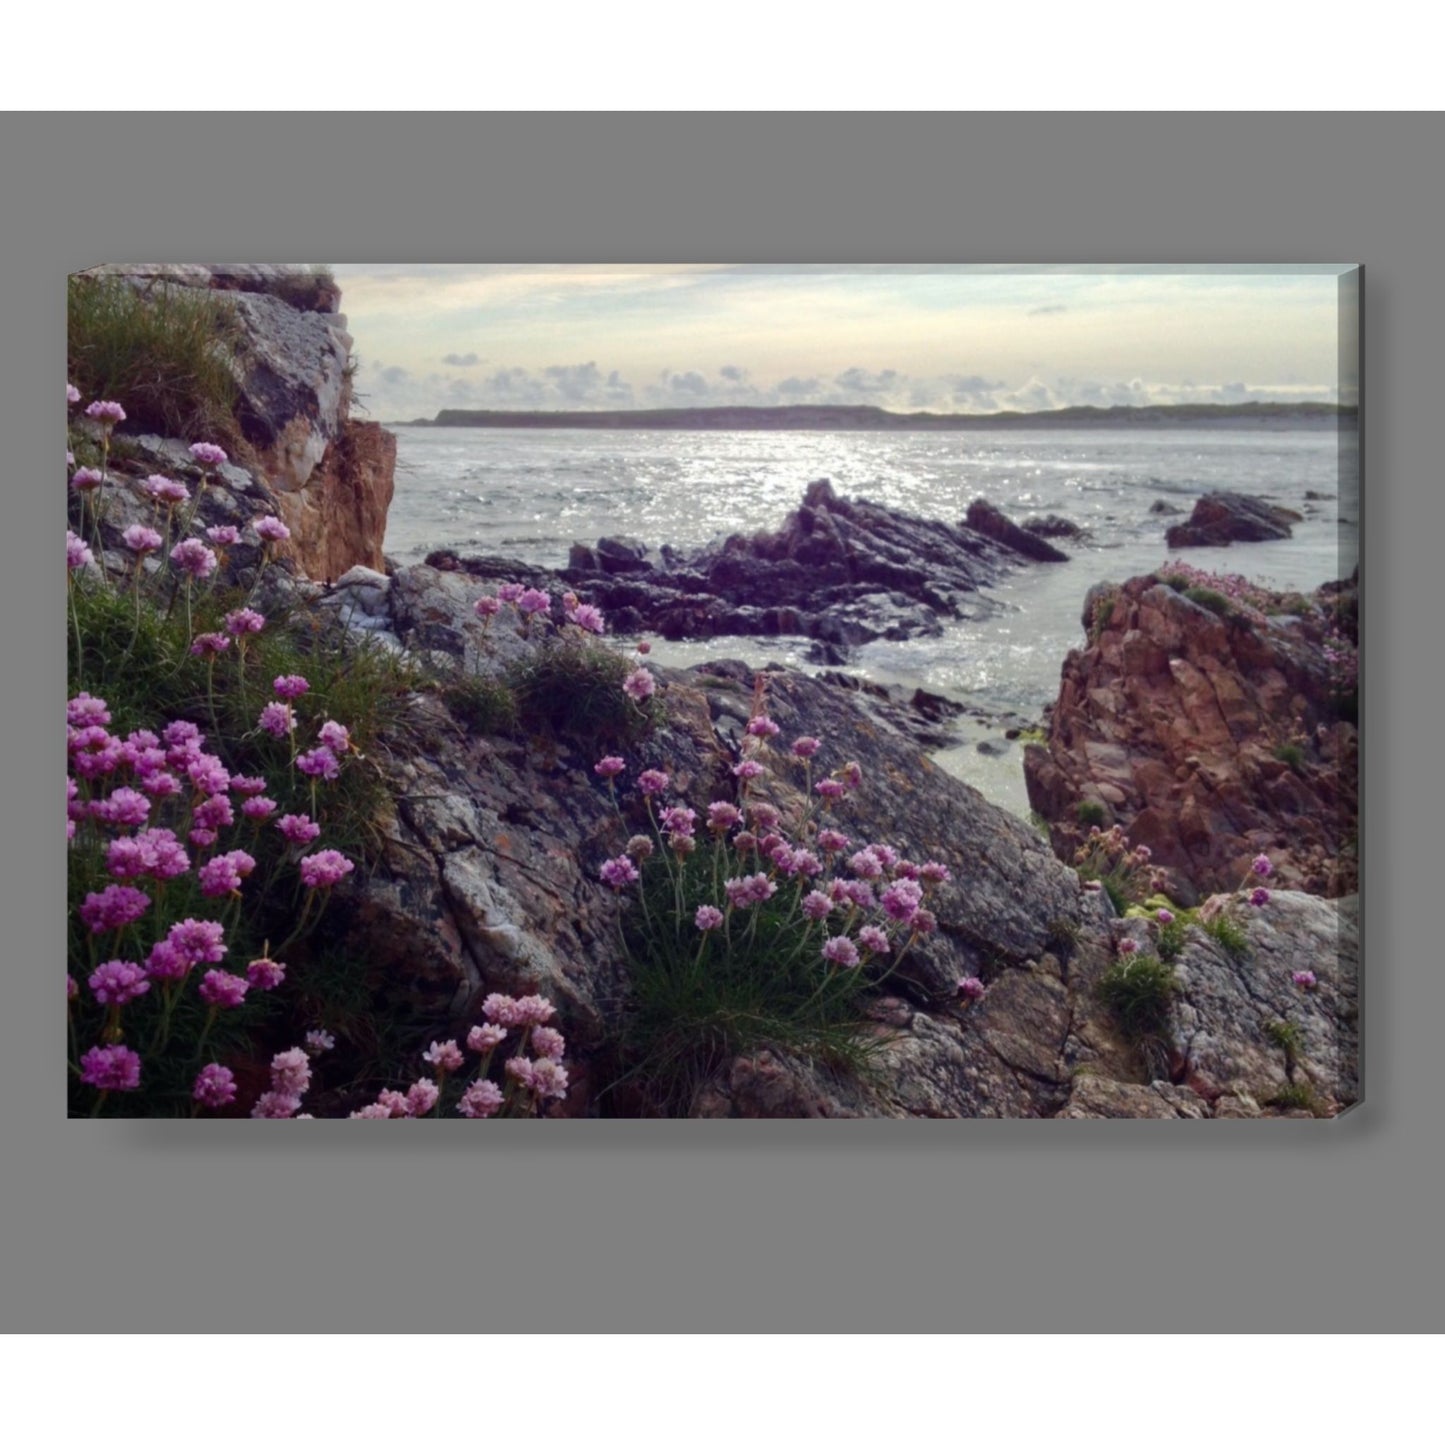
[332,264,1344,420]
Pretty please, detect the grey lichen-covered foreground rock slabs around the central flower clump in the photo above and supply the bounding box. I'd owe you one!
[290,566,1358,1118]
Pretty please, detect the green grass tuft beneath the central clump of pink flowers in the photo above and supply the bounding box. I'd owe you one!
[604,845,881,1116]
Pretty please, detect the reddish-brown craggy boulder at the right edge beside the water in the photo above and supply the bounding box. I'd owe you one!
[1025,577,1358,896]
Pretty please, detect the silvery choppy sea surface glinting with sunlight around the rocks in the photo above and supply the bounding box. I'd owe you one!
[386,426,1358,814]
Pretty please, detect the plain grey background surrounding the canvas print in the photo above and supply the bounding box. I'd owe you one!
[8,116,1445,1331]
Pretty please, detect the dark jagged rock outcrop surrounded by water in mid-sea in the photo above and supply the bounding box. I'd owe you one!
[445,480,1066,662]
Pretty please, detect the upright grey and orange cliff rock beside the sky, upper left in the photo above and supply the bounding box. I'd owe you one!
[72,266,396,579]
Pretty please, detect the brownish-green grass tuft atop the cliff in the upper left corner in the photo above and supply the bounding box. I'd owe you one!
[66,276,240,449]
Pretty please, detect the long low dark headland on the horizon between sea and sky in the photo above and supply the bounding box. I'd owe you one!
[387,402,1358,432]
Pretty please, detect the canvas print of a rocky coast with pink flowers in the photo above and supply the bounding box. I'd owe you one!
[65,263,1360,1127]
